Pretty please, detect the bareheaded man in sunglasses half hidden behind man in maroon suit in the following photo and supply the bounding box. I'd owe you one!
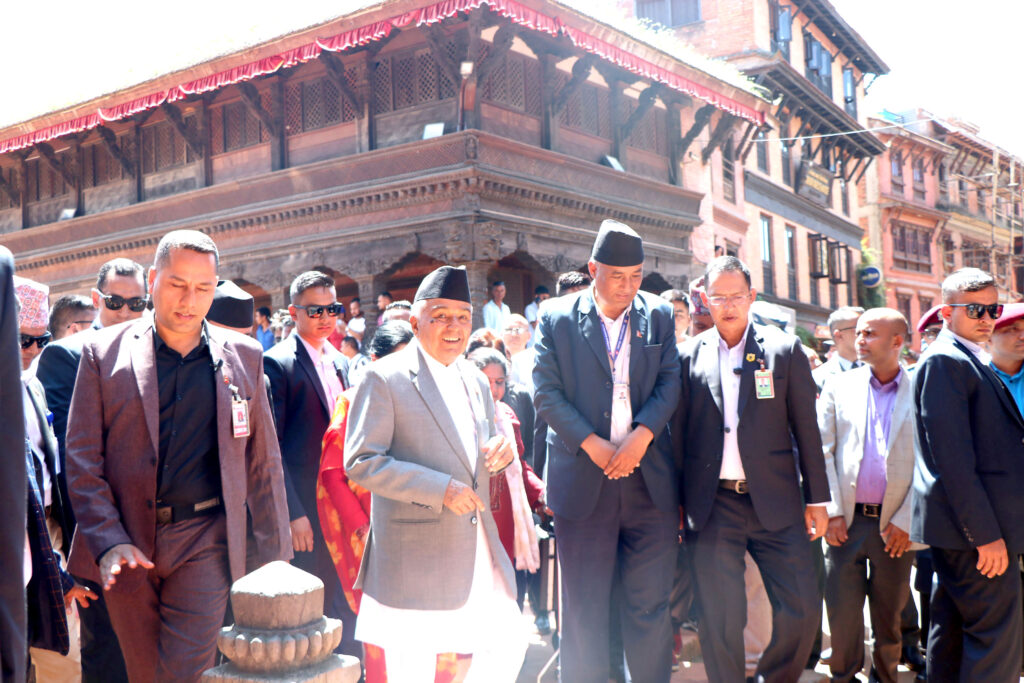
[36,258,148,683]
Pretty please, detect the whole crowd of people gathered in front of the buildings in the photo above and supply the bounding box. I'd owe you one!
[6,220,1024,683]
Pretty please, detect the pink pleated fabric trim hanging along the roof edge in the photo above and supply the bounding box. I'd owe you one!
[0,0,765,154]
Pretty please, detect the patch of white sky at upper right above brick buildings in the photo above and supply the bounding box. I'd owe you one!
[831,0,1024,157]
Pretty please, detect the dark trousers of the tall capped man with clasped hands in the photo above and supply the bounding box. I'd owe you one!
[555,472,679,683]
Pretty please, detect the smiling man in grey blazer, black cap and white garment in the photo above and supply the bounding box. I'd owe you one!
[345,266,525,683]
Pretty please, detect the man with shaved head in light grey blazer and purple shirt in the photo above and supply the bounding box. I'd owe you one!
[818,308,921,683]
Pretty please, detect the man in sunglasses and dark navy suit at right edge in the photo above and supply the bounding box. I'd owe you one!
[910,268,1024,683]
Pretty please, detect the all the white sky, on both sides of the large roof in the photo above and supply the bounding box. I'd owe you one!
[0,0,1024,157]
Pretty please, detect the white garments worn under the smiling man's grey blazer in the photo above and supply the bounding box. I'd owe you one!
[355,340,523,663]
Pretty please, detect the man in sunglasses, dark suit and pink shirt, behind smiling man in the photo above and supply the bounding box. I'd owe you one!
[263,270,359,654]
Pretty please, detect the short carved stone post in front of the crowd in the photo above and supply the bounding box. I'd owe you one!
[202,561,361,683]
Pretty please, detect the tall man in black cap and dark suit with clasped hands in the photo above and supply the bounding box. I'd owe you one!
[534,220,679,683]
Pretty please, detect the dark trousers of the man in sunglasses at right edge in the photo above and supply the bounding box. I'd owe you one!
[928,548,1024,683]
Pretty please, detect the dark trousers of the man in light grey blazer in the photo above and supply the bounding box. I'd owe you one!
[825,514,913,683]
